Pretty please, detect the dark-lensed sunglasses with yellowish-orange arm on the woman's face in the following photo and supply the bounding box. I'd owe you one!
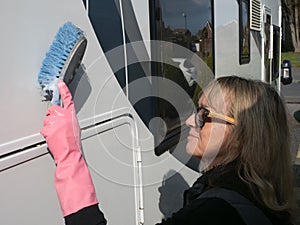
[194,106,235,128]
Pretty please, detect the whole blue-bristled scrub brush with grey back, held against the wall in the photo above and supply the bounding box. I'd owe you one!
[38,22,87,105]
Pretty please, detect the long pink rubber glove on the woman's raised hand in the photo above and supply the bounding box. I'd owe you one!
[40,81,98,217]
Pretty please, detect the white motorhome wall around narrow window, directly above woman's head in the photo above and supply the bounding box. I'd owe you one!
[214,0,261,79]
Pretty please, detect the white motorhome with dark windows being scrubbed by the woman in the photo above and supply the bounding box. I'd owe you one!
[0,0,281,225]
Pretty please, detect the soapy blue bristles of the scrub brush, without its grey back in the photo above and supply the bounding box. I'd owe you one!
[38,22,84,105]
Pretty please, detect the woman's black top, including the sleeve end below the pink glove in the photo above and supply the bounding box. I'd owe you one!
[65,163,290,225]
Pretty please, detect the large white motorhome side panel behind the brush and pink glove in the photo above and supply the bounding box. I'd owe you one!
[0,0,197,225]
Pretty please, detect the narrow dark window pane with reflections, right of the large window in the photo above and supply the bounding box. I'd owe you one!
[239,0,250,64]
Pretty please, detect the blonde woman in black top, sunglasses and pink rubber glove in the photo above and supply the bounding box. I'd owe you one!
[41,77,294,225]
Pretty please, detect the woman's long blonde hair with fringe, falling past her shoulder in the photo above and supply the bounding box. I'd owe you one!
[207,76,295,211]
